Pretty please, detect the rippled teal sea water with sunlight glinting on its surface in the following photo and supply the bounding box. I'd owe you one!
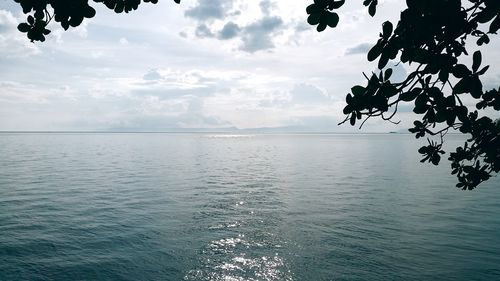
[0,133,500,280]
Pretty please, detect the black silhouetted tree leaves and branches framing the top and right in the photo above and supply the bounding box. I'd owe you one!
[14,0,500,190]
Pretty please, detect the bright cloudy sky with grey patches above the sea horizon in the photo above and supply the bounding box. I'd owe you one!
[0,0,500,132]
